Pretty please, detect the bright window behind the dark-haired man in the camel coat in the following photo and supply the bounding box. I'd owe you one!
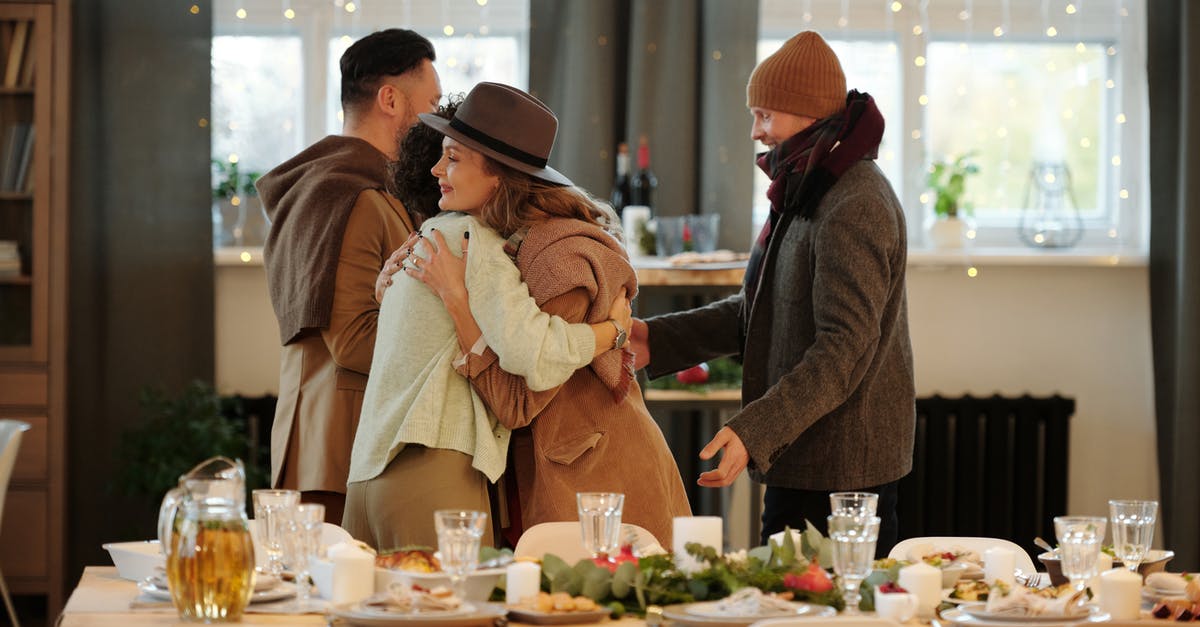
[211,0,529,244]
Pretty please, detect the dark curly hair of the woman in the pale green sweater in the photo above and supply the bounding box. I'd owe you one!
[390,94,464,222]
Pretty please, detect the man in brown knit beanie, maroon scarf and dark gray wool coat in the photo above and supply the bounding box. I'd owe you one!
[632,31,916,555]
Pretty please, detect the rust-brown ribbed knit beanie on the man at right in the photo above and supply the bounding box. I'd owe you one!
[746,30,846,120]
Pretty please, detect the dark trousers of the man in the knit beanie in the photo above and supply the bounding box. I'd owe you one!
[762,482,900,557]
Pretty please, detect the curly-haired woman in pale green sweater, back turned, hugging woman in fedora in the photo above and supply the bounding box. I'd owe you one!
[342,92,631,549]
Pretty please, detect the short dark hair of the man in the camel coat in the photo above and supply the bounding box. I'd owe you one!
[340,29,437,111]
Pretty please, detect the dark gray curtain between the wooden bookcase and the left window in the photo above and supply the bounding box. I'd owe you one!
[62,0,214,585]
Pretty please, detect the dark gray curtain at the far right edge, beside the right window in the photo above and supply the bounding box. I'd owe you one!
[1147,0,1200,571]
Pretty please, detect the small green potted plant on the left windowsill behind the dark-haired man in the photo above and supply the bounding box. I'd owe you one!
[212,159,266,247]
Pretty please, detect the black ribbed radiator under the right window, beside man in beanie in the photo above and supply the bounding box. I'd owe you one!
[898,395,1075,555]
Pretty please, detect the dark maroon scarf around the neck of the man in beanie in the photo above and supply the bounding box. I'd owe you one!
[743,90,883,305]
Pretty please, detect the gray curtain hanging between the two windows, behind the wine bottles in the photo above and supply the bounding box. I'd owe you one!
[529,0,758,250]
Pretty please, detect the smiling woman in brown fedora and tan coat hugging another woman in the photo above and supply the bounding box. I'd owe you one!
[391,83,691,545]
